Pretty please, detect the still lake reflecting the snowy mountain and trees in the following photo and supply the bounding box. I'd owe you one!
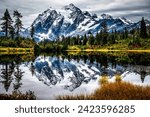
[0,52,150,100]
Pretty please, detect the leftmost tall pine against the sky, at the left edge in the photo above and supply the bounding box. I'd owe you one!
[1,9,13,37]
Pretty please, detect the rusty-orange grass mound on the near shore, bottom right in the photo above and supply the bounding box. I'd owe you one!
[57,82,150,100]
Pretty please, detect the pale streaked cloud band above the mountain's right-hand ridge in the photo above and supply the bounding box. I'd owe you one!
[93,4,150,21]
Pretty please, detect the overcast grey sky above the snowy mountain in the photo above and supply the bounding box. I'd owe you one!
[0,0,150,27]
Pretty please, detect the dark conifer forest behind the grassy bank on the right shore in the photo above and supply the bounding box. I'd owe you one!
[57,17,150,46]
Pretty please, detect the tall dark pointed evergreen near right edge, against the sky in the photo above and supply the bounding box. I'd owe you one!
[140,17,147,38]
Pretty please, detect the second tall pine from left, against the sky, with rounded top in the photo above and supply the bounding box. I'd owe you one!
[13,10,23,37]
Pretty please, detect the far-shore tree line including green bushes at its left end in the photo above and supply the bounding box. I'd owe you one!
[39,17,150,50]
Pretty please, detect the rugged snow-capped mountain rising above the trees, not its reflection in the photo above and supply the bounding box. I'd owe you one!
[25,4,148,41]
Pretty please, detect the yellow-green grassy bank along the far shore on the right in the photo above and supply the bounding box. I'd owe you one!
[67,39,150,52]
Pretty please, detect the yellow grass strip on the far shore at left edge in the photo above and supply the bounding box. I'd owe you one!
[0,47,34,54]
